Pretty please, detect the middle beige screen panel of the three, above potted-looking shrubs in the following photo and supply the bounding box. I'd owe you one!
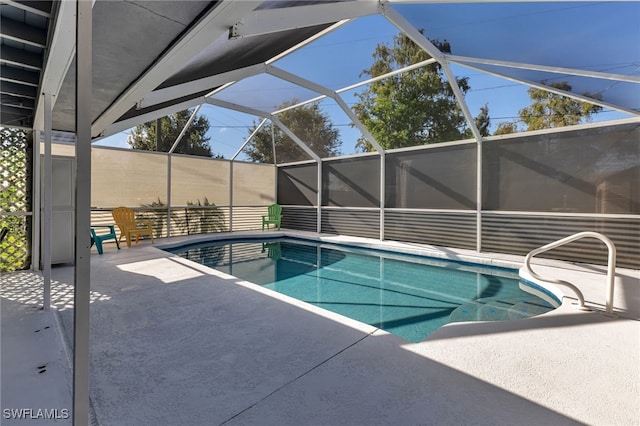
[171,155,230,206]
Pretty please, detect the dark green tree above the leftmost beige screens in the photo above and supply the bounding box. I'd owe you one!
[127,110,220,157]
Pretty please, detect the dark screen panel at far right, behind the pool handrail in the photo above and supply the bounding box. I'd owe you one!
[483,124,640,214]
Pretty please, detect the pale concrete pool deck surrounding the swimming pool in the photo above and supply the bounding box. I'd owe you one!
[0,233,640,426]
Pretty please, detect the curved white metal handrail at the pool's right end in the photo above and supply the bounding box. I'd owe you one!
[524,231,616,314]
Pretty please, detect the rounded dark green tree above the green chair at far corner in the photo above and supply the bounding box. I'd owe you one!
[245,100,342,163]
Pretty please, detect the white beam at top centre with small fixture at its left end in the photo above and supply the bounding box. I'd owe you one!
[229,0,379,39]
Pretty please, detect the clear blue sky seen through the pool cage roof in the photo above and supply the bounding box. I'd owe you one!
[97,2,640,159]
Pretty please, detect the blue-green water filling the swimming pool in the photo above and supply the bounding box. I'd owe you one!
[169,239,554,342]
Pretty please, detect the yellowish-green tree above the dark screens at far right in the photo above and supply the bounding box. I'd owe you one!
[494,81,602,135]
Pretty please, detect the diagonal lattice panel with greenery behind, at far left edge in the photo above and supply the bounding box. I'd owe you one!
[0,128,30,272]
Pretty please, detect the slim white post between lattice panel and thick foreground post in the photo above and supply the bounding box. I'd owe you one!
[42,93,53,311]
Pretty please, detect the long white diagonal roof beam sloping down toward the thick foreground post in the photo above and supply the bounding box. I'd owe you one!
[91,0,262,136]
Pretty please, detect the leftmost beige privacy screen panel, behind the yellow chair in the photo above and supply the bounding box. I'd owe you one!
[91,147,167,208]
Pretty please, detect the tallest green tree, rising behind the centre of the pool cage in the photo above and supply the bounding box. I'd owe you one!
[354,34,472,151]
